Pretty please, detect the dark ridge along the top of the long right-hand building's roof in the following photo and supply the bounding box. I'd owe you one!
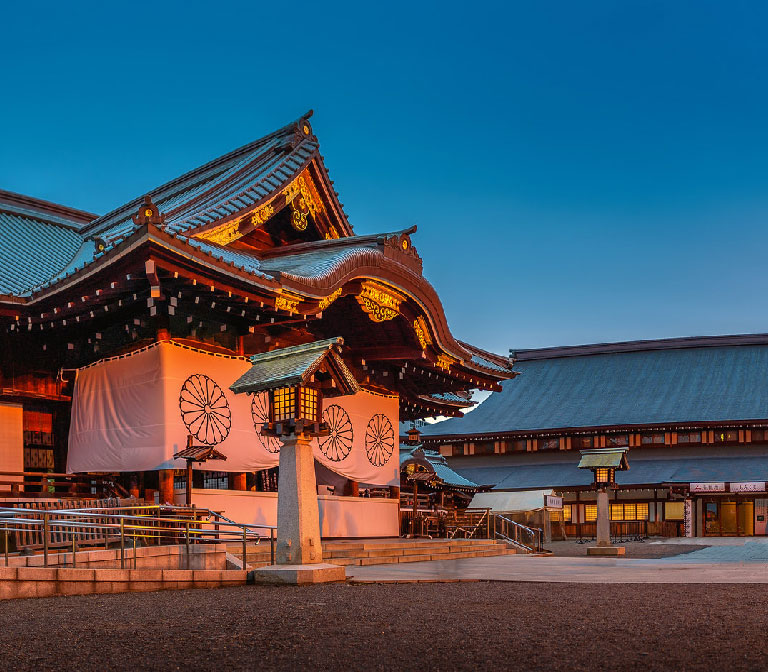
[509,333,768,361]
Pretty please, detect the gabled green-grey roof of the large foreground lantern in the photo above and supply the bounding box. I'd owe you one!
[229,337,359,397]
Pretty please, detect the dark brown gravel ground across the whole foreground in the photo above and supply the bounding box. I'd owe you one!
[0,582,768,672]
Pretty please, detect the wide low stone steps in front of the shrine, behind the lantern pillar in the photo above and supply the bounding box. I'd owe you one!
[227,539,516,569]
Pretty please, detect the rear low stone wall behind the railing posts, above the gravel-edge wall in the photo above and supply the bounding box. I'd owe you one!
[6,544,227,569]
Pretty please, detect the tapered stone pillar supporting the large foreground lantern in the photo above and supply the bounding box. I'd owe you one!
[275,434,323,565]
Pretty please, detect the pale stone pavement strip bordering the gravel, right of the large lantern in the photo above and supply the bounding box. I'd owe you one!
[347,542,768,583]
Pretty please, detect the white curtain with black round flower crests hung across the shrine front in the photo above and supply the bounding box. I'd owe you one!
[67,342,399,485]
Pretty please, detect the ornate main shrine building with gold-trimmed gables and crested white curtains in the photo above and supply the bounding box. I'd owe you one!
[0,113,515,537]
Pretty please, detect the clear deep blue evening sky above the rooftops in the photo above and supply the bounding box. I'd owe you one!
[0,0,768,353]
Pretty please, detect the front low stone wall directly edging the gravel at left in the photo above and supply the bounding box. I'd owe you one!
[0,567,247,600]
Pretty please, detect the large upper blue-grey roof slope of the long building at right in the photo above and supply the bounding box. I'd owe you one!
[423,335,768,436]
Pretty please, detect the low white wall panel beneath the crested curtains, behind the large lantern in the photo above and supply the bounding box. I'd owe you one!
[175,488,400,538]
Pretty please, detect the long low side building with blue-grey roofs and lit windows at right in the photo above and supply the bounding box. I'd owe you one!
[421,334,768,537]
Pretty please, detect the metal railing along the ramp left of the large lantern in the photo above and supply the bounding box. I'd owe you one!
[0,505,277,569]
